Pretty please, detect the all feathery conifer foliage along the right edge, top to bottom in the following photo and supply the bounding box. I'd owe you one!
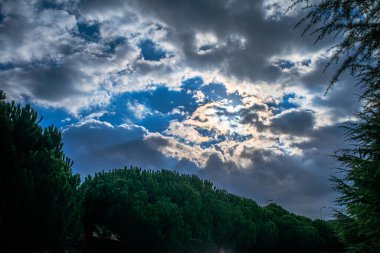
[293,0,380,252]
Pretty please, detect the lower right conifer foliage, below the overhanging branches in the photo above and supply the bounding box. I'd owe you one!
[333,108,380,252]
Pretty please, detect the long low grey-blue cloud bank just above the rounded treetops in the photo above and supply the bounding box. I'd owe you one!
[63,116,343,218]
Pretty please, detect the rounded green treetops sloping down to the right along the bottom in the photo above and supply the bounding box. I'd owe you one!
[81,168,339,252]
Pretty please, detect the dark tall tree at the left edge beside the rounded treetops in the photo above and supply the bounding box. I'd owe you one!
[0,91,80,252]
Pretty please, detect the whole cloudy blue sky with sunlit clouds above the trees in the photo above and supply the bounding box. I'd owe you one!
[0,0,359,218]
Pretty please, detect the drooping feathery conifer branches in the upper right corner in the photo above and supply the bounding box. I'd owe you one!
[290,0,380,92]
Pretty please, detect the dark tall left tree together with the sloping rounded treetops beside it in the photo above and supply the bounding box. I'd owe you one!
[0,92,342,252]
